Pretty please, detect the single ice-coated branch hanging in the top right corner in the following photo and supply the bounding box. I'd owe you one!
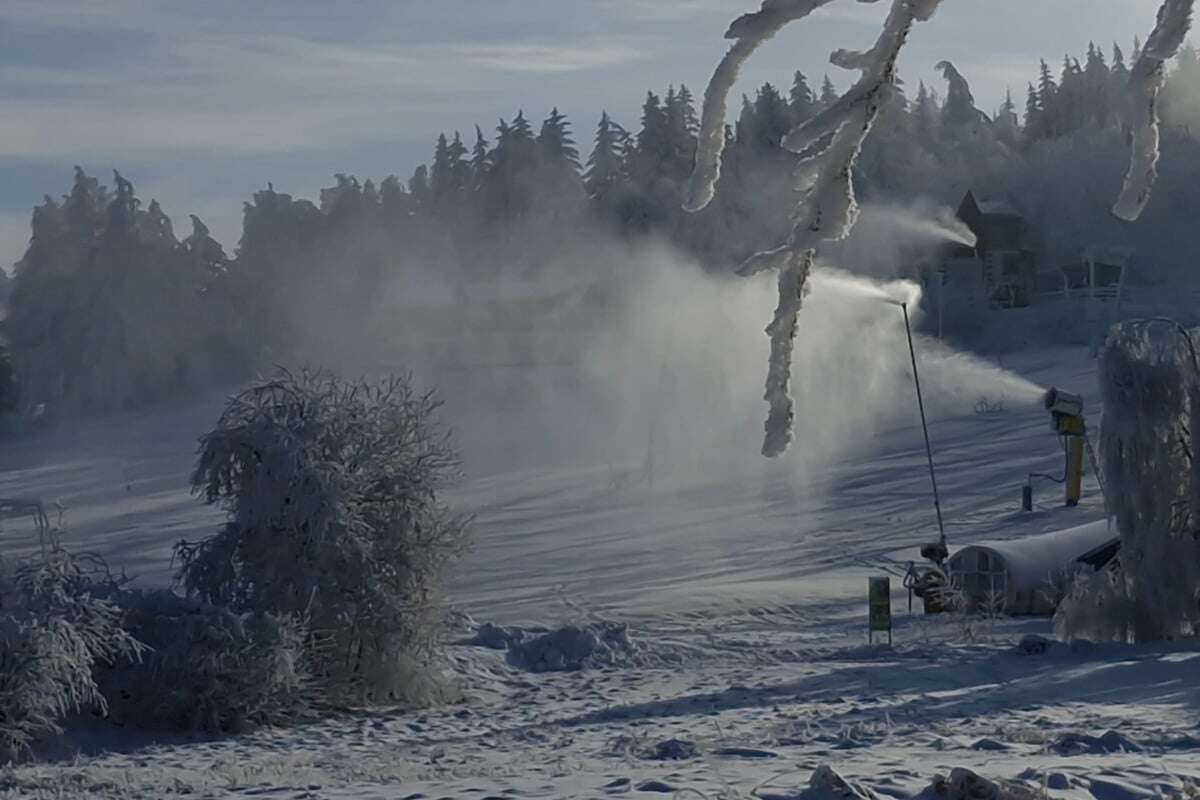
[1112,0,1194,222]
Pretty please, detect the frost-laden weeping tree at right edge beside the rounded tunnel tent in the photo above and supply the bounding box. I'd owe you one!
[1058,320,1200,642]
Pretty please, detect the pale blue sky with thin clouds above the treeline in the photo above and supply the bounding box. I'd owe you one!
[0,0,1158,264]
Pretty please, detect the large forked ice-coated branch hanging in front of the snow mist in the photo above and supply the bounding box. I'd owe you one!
[685,0,941,457]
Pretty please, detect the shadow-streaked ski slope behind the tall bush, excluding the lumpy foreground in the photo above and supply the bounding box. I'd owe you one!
[0,340,1102,624]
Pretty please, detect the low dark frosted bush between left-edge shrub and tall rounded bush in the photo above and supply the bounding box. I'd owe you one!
[97,591,312,734]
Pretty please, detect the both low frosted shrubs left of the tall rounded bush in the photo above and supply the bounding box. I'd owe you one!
[0,542,312,758]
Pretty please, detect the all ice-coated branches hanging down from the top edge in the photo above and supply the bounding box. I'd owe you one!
[684,0,1171,457]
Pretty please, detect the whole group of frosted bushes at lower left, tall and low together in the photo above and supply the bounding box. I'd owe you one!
[0,372,467,757]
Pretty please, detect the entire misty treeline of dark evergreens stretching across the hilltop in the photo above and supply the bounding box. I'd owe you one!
[5,40,1200,413]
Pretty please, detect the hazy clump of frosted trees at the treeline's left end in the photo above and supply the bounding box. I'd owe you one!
[6,168,231,414]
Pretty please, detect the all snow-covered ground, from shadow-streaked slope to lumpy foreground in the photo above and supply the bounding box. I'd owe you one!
[0,349,1200,800]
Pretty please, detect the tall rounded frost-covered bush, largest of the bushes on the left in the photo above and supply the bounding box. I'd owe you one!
[178,371,467,700]
